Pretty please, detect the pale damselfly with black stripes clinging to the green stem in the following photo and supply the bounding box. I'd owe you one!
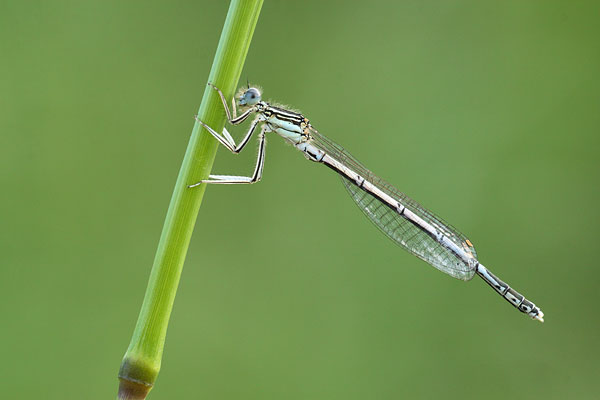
[189,84,544,322]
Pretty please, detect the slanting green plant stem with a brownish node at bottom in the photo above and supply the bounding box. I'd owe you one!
[119,0,263,399]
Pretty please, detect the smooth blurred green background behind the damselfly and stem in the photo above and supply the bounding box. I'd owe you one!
[0,0,600,399]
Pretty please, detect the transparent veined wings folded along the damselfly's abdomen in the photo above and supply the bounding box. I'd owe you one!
[311,129,477,280]
